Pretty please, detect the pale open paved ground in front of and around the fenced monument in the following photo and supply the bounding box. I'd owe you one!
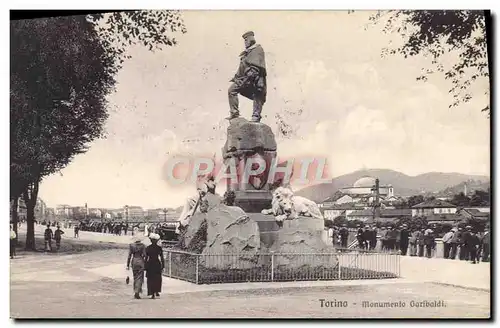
[11,226,490,318]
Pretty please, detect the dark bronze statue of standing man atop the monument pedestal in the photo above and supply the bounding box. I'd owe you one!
[227,32,267,122]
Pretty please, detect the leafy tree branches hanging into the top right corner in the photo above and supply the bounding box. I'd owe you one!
[370,10,490,117]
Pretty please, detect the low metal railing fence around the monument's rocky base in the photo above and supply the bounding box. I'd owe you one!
[164,249,400,284]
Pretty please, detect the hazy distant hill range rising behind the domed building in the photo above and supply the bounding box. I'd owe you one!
[296,169,490,202]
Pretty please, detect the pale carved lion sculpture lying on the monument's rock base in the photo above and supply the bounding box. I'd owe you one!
[261,187,323,222]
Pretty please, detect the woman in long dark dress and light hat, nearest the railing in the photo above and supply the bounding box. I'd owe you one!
[146,233,165,299]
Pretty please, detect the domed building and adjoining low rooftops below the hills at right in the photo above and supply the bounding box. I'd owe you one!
[319,177,490,223]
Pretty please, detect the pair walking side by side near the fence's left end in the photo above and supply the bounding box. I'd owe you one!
[127,233,165,299]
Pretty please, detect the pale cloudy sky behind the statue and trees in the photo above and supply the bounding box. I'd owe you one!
[39,11,490,208]
